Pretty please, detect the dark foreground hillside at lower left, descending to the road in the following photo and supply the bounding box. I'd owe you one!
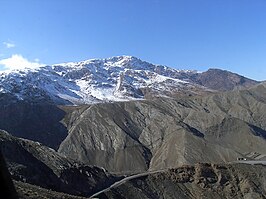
[0,131,119,196]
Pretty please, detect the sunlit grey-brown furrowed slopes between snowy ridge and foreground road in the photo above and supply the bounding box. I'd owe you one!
[58,84,266,173]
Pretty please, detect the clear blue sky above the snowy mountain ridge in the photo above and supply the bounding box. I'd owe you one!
[0,0,266,80]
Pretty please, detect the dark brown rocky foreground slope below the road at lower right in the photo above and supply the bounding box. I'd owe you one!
[97,164,266,199]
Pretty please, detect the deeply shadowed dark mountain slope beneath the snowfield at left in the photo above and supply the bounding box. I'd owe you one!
[0,102,67,149]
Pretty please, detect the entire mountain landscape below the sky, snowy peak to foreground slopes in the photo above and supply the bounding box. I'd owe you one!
[0,56,266,198]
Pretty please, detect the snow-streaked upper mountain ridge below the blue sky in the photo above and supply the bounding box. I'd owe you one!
[0,56,258,104]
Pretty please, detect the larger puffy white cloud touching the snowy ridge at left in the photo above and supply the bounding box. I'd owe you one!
[0,54,44,70]
